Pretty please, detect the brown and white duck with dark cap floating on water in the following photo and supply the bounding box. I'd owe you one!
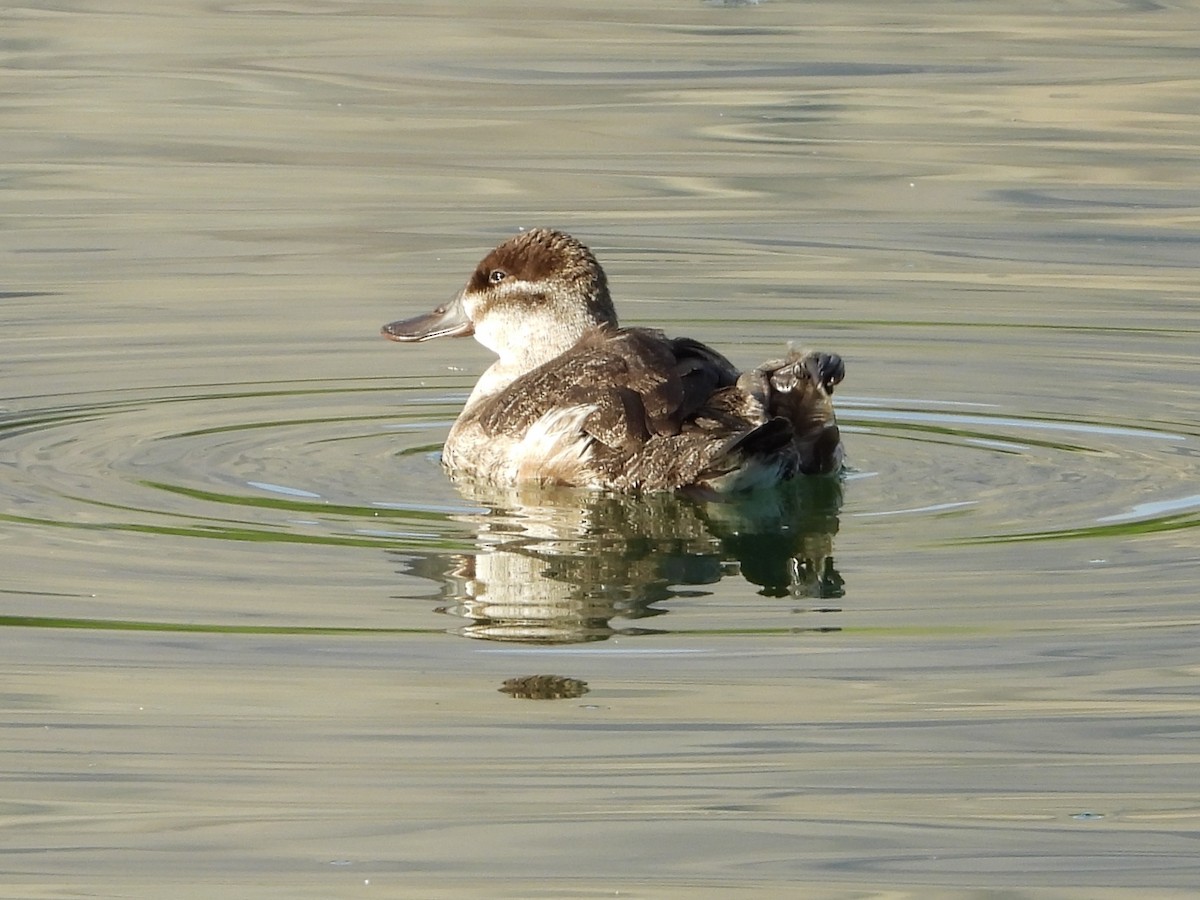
[383,228,845,493]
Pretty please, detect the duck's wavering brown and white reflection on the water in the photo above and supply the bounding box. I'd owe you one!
[396,478,842,643]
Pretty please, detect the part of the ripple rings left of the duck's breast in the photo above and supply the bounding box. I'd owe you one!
[0,379,474,554]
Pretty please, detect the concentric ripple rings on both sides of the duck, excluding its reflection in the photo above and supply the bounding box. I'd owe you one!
[0,378,1200,550]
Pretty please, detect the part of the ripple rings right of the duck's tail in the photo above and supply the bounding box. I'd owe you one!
[839,398,1200,542]
